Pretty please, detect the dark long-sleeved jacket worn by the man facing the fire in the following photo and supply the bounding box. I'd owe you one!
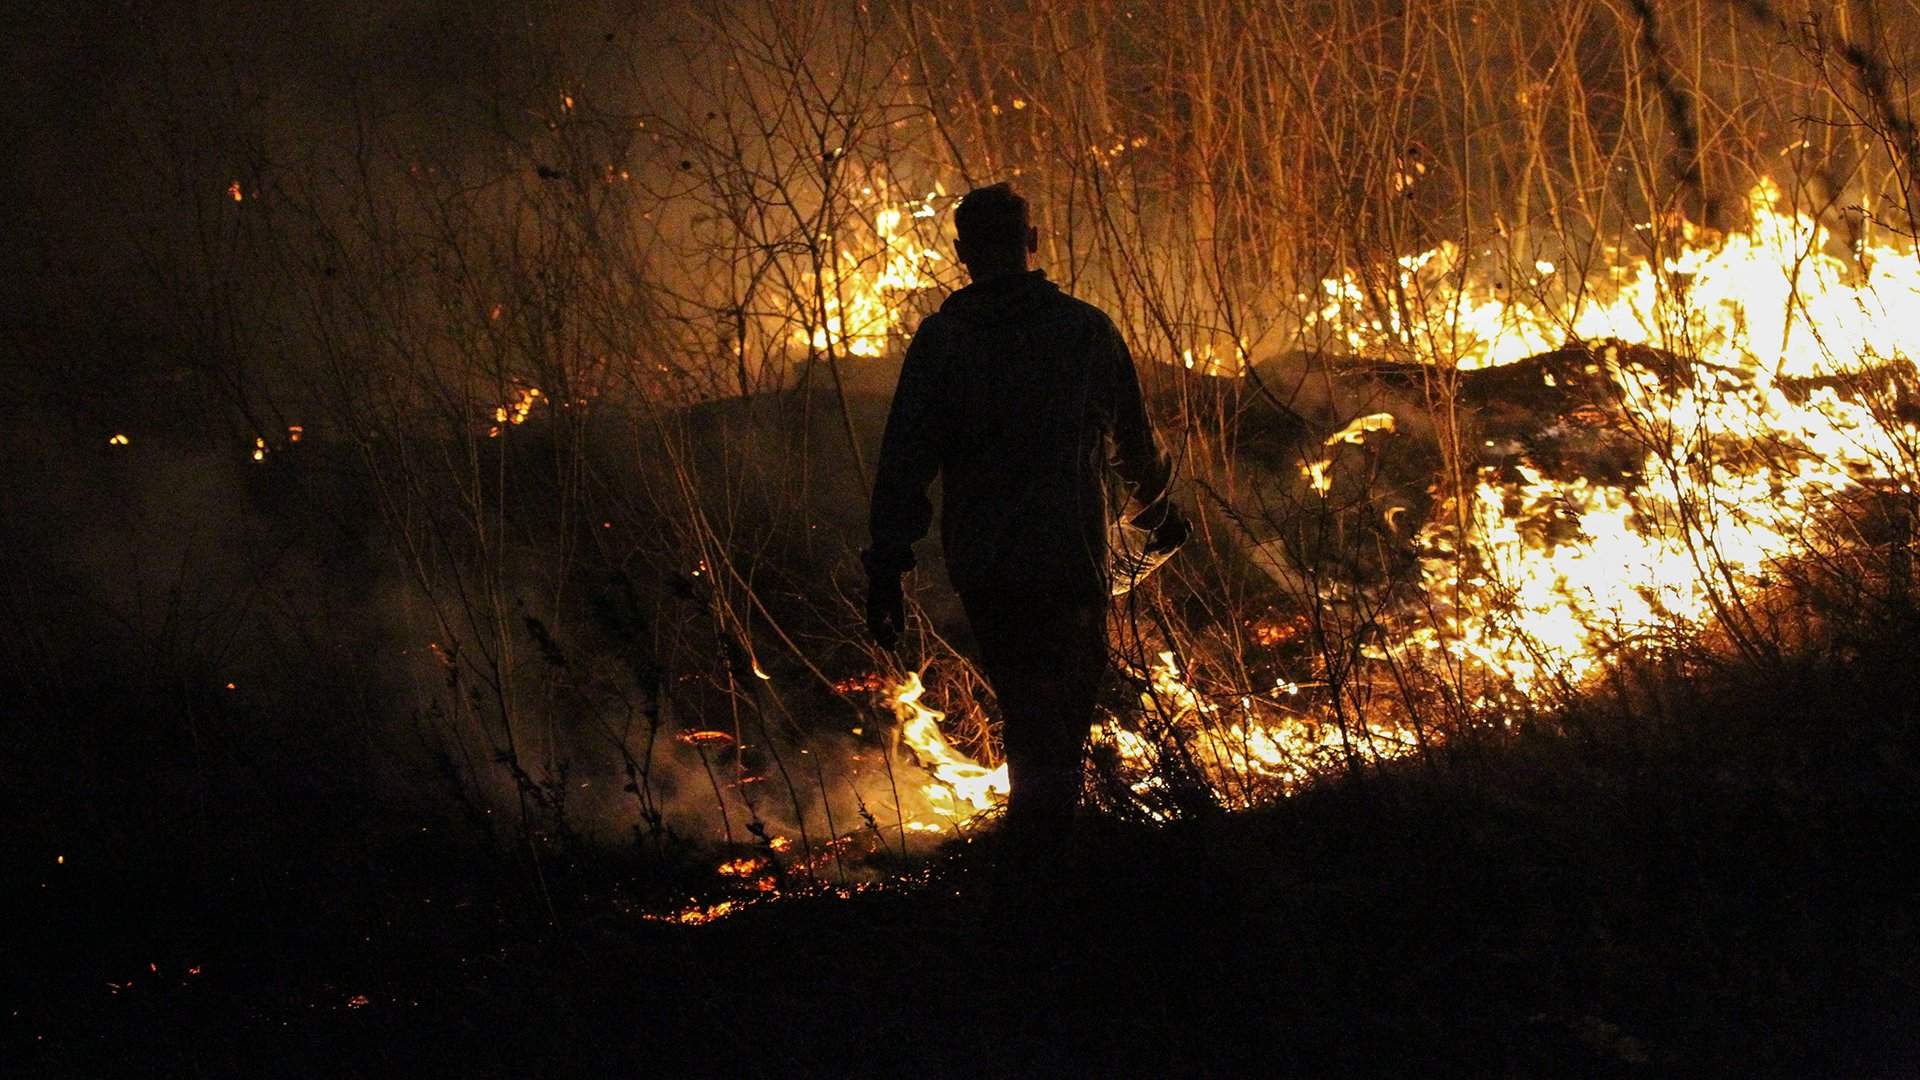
[866,271,1171,598]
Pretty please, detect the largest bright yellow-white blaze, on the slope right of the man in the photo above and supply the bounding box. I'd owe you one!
[1304,181,1920,700]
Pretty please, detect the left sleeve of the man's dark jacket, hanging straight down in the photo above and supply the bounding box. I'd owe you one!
[860,315,947,577]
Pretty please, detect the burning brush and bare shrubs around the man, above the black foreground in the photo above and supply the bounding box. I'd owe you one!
[10,0,1920,1045]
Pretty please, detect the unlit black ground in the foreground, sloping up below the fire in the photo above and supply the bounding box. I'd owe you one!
[6,650,1920,1076]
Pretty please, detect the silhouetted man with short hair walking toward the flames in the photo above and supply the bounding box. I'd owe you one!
[862,184,1187,895]
